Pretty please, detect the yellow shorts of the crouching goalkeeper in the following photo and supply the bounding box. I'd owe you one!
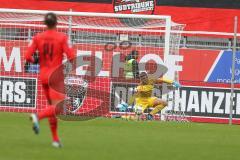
[136,97,157,111]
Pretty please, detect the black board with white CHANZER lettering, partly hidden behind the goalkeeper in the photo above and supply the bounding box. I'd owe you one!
[110,83,240,118]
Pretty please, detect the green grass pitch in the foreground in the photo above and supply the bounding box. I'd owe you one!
[0,113,240,160]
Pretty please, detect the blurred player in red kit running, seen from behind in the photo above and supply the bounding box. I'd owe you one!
[25,13,75,148]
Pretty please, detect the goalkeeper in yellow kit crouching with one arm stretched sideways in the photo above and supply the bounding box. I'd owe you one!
[129,72,181,120]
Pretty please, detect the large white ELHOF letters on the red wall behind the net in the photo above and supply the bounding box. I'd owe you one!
[73,50,183,78]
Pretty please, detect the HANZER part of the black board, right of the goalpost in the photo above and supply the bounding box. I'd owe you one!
[168,86,240,118]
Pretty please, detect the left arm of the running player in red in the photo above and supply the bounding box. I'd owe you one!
[25,37,38,63]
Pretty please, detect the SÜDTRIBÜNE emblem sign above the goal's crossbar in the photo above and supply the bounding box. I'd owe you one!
[113,0,155,14]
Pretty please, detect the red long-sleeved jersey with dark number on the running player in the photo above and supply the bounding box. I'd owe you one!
[25,29,75,84]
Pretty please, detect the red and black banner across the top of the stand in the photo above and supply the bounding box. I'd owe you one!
[0,0,240,33]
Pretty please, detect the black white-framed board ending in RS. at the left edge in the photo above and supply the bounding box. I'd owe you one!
[0,76,37,108]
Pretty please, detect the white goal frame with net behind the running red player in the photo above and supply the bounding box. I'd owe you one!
[0,9,184,120]
